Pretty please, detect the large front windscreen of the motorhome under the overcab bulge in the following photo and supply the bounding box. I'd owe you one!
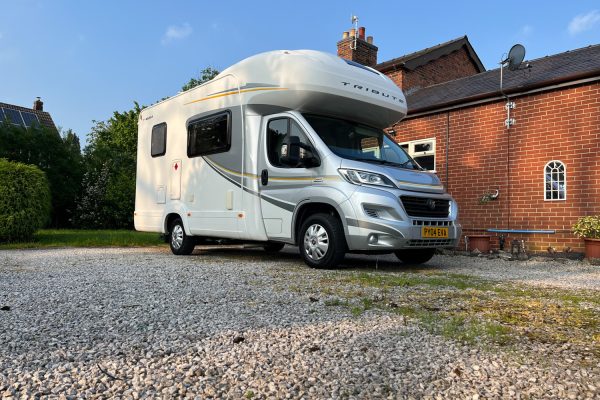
[304,114,421,170]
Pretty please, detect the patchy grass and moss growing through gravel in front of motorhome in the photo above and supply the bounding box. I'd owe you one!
[310,272,600,357]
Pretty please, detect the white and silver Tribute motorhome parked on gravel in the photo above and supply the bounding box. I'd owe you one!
[134,50,461,268]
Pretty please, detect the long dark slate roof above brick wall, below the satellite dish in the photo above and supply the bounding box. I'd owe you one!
[406,45,600,116]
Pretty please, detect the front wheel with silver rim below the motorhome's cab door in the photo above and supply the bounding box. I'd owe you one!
[298,214,346,268]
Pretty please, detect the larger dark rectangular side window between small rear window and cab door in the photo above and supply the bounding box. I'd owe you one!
[188,111,231,157]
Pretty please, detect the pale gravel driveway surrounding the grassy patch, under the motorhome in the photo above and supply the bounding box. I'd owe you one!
[0,248,600,399]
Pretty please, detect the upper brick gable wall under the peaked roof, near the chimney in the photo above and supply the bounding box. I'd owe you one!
[402,47,479,93]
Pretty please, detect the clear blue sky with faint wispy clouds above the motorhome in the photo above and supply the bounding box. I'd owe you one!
[0,0,600,146]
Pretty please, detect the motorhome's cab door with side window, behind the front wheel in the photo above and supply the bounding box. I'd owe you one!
[258,113,315,240]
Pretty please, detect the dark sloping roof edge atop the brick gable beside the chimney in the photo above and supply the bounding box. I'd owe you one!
[374,36,485,73]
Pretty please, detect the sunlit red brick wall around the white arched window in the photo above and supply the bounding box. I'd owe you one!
[394,83,600,251]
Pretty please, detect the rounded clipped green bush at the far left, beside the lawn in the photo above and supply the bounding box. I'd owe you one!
[0,158,50,242]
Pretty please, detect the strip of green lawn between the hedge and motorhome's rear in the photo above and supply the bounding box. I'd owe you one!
[0,229,164,249]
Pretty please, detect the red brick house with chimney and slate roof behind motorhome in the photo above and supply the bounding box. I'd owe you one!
[338,28,600,252]
